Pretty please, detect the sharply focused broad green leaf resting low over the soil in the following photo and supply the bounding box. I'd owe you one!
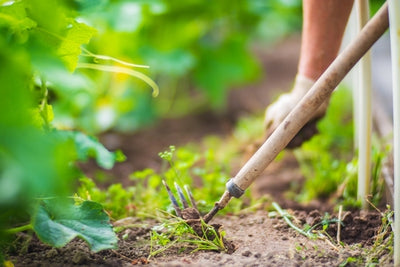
[32,199,118,252]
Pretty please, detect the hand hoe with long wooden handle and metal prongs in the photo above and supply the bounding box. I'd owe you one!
[164,3,389,223]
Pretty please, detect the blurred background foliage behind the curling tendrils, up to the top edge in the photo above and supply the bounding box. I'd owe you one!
[65,0,301,132]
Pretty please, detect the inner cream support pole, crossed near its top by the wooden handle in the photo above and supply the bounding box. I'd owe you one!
[357,0,372,209]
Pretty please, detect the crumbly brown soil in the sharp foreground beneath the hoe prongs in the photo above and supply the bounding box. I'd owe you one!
[6,210,393,266]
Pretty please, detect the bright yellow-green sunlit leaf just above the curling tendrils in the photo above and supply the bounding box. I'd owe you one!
[57,20,95,71]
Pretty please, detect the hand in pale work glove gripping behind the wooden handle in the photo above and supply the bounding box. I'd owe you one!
[264,75,329,148]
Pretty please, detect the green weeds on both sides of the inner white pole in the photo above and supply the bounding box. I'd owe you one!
[295,88,385,207]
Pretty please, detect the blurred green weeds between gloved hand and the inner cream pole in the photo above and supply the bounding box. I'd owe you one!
[295,88,357,202]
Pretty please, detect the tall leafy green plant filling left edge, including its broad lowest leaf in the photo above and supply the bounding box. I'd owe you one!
[0,0,159,261]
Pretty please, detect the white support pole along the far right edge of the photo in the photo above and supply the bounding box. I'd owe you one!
[388,0,400,267]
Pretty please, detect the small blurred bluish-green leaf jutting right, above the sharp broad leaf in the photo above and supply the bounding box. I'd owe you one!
[59,131,125,169]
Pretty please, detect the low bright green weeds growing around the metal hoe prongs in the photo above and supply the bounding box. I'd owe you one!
[77,145,248,222]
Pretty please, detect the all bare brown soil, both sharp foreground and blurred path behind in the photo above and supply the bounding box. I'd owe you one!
[8,36,393,266]
